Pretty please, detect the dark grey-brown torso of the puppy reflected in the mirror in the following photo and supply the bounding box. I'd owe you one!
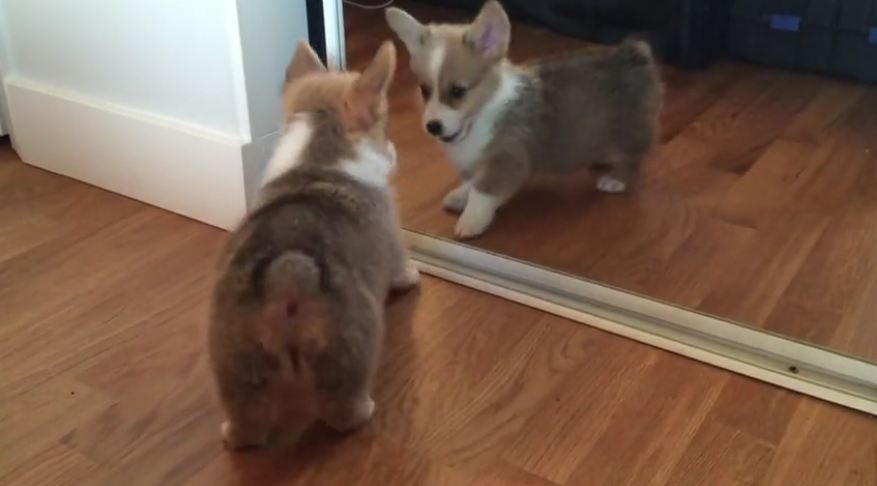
[518,40,662,171]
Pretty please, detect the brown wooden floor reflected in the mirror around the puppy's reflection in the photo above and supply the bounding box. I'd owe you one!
[346,2,877,360]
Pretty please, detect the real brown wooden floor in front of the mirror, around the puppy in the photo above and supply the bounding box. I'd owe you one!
[0,137,877,486]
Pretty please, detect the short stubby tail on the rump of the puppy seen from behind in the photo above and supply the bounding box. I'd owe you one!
[264,251,321,310]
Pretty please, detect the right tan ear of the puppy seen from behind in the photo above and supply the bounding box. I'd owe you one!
[344,40,396,126]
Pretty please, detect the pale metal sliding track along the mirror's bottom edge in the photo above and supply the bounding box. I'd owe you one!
[405,231,877,415]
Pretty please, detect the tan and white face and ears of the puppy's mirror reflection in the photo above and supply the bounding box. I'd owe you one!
[386,0,511,143]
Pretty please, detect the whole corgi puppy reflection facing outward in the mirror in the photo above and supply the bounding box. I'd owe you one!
[386,0,662,238]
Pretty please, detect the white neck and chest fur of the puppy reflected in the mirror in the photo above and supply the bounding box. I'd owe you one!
[442,67,523,172]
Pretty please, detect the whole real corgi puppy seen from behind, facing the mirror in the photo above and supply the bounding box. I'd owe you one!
[208,41,418,449]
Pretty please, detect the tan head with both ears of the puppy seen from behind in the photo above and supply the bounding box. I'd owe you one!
[283,41,396,160]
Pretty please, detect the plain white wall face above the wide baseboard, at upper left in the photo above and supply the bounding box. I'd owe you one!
[4,0,246,137]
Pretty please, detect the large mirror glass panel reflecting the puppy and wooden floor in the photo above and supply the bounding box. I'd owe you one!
[345,0,877,360]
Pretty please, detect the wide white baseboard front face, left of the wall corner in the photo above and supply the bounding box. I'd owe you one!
[6,76,253,229]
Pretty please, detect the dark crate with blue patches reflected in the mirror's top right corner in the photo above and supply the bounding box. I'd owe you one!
[727,0,877,82]
